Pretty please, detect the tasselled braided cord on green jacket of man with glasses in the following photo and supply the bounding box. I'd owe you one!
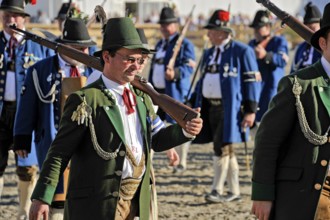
[71,97,122,160]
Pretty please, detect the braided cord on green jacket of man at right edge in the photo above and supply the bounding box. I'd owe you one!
[292,76,330,145]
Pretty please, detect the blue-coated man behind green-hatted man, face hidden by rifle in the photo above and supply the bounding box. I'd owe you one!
[14,15,95,218]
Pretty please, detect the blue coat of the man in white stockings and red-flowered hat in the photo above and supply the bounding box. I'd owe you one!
[192,40,261,143]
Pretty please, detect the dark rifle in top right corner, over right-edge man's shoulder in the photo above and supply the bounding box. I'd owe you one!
[256,0,313,44]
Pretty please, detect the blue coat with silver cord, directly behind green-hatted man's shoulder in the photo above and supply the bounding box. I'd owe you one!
[14,55,92,166]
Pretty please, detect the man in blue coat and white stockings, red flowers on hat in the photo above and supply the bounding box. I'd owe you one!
[191,10,260,203]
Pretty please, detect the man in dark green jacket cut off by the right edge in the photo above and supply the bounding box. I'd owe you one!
[252,4,330,220]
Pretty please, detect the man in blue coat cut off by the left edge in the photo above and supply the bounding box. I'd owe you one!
[0,0,52,219]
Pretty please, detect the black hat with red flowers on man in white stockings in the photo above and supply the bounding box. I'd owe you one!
[204,9,233,33]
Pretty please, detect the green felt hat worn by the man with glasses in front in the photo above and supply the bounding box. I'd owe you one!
[94,17,145,56]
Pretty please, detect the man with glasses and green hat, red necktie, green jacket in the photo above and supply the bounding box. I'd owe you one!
[30,18,202,220]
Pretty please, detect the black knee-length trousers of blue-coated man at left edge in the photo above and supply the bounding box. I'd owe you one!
[0,101,17,177]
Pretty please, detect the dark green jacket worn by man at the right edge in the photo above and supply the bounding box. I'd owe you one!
[252,61,330,220]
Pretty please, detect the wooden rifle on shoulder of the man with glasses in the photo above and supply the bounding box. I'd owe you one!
[10,25,200,128]
